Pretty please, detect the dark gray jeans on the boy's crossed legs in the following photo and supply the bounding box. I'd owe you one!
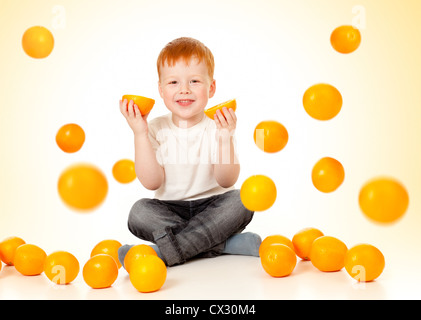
[128,190,254,266]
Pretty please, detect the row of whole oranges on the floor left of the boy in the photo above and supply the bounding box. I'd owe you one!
[0,237,167,292]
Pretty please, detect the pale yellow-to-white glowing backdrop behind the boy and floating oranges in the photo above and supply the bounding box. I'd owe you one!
[0,0,421,297]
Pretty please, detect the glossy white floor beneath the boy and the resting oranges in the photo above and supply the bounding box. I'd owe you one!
[0,252,421,300]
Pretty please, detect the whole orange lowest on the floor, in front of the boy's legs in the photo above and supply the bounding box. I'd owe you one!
[130,255,167,293]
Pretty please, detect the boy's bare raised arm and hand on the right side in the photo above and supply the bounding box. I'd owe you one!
[214,108,240,188]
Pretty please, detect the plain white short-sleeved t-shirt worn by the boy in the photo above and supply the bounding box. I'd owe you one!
[148,113,235,200]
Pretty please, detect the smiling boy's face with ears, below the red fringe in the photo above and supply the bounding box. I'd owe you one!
[158,58,216,127]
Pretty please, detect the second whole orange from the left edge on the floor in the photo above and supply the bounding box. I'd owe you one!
[13,244,47,276]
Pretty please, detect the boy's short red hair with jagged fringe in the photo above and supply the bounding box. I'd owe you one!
[156,37,215,79]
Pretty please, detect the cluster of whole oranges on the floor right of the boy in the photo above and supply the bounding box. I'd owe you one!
[259,228,385,282]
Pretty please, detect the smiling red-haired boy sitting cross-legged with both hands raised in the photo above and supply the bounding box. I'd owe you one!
[119,37,261,266]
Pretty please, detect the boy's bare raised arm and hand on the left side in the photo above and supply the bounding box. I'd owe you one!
[120,100,164,190]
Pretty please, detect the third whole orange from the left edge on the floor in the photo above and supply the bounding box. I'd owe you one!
[44,251,80,284]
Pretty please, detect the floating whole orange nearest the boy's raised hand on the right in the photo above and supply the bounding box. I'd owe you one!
[254,120,288,153]
